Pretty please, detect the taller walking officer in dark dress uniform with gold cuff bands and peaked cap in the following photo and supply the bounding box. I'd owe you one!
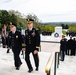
[22,19,40,73]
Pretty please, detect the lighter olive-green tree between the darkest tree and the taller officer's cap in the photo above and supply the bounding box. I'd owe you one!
[9,10,26,29]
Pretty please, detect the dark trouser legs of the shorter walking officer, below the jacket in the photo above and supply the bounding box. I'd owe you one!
[13,50,22,67]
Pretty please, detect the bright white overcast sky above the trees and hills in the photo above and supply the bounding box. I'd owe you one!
[0,0,76,22]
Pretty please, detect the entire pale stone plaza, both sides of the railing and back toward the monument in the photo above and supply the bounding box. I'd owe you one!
[0,36,76,75]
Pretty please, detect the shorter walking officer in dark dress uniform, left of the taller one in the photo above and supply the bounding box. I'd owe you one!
[8,23,24,70]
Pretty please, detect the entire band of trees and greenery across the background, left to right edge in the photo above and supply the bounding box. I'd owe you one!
[0,10,76,33]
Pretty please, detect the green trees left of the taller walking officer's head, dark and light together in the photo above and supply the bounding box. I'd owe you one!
[0,10,26,29]
